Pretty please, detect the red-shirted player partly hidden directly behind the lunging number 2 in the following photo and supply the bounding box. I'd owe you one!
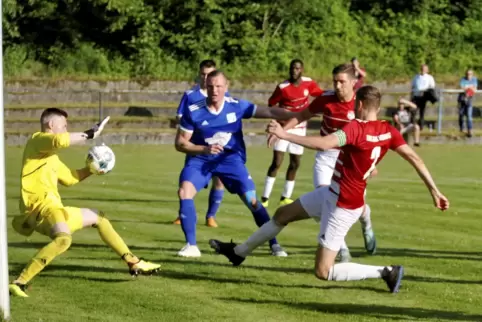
[269,63,377,262]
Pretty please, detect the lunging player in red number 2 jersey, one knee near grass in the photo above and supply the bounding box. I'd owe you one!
[210,86,449,293]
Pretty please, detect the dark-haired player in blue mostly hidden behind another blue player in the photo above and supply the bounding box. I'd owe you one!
[173,59,229,228]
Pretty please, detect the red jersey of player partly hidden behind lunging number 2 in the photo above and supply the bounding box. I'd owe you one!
[308,91,355,136]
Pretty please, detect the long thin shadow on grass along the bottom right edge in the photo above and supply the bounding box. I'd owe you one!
[218,297,482,321]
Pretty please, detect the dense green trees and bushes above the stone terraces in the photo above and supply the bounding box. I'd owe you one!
[3,0,482,80]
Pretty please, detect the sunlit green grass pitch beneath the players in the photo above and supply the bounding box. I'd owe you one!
[6,145,482,322]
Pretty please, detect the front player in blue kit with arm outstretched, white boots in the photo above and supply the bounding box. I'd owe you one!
[175,70,302,257]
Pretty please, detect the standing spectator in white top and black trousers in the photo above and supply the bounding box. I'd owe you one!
[412,64,437,130]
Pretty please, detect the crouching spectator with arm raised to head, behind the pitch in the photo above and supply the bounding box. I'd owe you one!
[392,98,420,146]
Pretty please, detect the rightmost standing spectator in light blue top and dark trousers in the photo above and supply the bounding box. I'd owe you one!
[457,69,478,138]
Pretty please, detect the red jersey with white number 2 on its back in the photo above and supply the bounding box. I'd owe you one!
[330,120,406,209]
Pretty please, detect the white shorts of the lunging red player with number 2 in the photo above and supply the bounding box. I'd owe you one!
[300,187,364,252]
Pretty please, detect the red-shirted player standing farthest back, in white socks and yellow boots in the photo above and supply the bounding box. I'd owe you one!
[261,59,323,207]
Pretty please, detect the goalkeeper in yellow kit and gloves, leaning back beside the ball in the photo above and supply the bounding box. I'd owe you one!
[9,108,160,297]
